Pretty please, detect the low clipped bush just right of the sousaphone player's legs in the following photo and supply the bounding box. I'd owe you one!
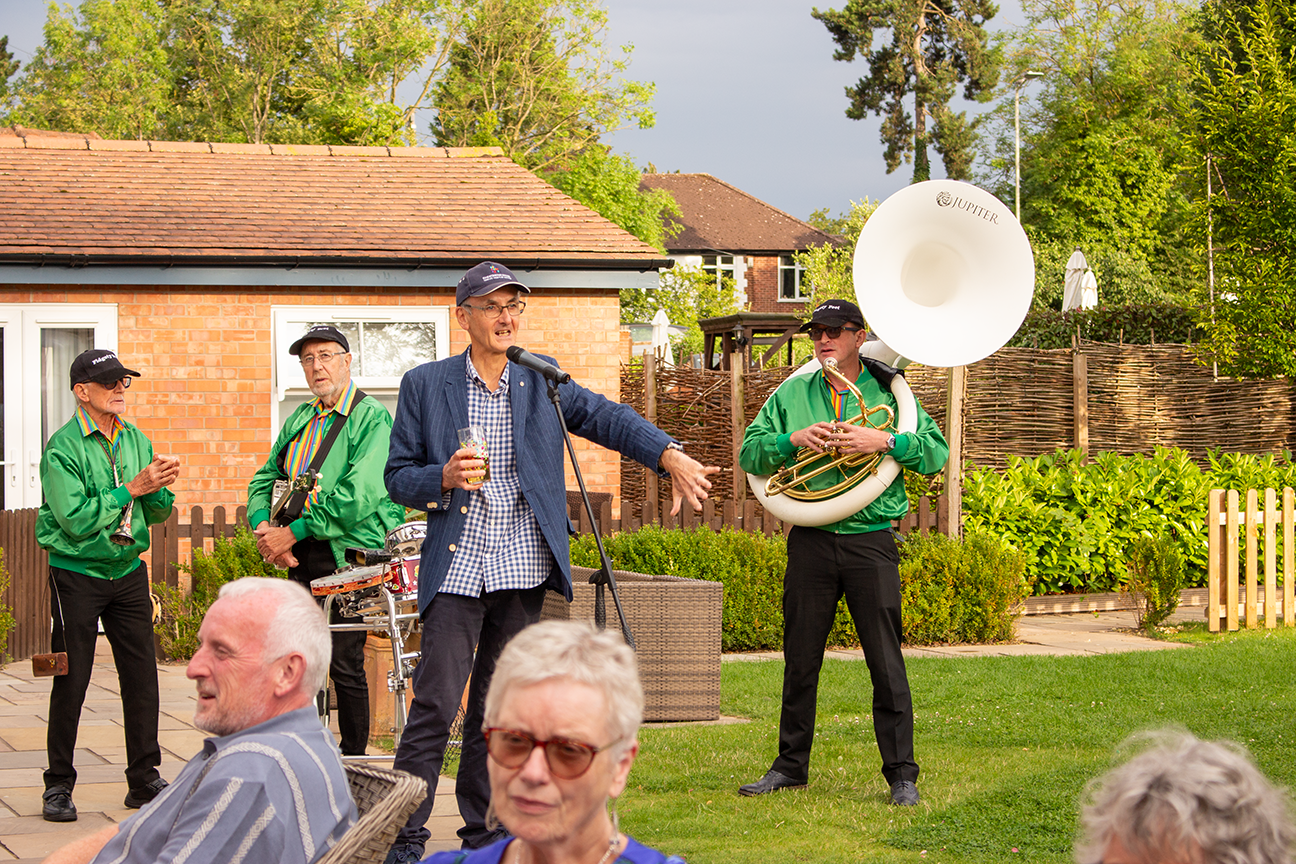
[899,532,1030,645]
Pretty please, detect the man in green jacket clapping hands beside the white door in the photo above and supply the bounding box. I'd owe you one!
[35,348,180,823]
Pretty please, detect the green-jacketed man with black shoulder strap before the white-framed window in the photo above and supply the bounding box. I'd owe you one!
[248,324,404,756]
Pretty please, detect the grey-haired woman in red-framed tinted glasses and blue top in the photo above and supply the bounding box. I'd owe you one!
[424,620,683,864]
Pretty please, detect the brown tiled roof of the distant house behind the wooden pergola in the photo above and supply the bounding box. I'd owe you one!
[640,174,841,255]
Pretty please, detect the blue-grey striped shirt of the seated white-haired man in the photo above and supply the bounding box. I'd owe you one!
[93,705,356,864]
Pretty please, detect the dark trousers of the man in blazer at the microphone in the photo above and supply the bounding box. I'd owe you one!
[394,585,544,848]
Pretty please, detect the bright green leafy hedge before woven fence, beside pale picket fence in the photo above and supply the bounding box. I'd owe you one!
[963,448,1296,595]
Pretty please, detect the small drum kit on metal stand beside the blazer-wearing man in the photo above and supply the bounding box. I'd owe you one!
[311,522,426,744]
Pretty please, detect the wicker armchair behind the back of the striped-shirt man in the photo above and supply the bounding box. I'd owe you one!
[316,763,428,864]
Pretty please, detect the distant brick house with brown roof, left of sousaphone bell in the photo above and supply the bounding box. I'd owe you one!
[640,174,842,315]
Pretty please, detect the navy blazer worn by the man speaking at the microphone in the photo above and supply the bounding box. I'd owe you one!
[384,351,671,614]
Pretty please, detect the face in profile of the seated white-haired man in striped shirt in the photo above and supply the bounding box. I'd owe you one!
[185,593,281,736]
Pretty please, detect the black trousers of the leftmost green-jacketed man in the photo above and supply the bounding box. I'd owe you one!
[45,563,162,791]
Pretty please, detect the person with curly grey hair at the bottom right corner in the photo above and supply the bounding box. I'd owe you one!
[1076,732,1296,864]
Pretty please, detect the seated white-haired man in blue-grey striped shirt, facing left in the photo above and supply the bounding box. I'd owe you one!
[45,578,356,864]
